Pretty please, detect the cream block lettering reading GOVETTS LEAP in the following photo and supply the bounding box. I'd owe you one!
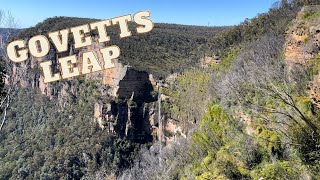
[7,11,154,83]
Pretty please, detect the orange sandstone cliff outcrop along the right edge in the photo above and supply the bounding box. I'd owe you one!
[284,6,320,108]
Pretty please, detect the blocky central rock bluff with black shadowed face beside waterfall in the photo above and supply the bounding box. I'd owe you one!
[94,65,157,142]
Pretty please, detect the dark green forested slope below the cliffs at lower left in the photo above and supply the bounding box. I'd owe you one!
[0,85,141,179]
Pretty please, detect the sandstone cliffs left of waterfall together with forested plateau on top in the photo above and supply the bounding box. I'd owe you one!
[6,17,225,142]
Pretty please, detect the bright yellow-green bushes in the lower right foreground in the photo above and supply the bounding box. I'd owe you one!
[174,98,314,180]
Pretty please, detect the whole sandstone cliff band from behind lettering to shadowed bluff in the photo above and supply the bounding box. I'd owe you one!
[6,35,161,142]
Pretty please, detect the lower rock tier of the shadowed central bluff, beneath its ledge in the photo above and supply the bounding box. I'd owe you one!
[94,95,157,142]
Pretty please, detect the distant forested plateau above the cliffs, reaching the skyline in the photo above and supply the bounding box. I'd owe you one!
[16,17,227,78]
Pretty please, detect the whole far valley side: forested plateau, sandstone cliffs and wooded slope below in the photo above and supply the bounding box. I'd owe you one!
[0,17,226,179]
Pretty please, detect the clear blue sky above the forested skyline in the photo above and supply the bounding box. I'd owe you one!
[0,0,277,28]
